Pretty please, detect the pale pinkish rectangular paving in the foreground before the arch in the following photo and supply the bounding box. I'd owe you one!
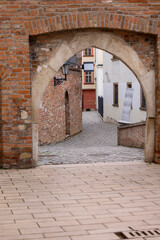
[0,162,160,240]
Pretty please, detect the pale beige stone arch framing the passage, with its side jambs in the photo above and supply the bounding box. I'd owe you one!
[32,32,155,166]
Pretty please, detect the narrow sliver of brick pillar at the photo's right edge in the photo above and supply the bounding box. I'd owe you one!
[155,35,160,163]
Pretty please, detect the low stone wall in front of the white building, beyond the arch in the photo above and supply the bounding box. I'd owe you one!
[118,122,146,148]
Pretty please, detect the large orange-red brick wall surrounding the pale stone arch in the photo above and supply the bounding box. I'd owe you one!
[0,0,160,168]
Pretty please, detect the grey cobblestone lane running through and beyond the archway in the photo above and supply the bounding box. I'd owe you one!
[38,111,144,165]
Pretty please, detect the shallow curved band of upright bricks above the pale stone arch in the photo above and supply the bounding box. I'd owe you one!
[22,11,160,36]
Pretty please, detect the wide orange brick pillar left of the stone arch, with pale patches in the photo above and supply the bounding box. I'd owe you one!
[0,35,32,168]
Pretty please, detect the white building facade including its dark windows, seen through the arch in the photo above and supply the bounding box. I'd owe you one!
[95,49,146,123]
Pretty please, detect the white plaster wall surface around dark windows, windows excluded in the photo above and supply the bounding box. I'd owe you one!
[103,52,146,123]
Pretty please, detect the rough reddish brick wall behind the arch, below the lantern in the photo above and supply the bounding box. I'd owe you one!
[39,69,82,144]
